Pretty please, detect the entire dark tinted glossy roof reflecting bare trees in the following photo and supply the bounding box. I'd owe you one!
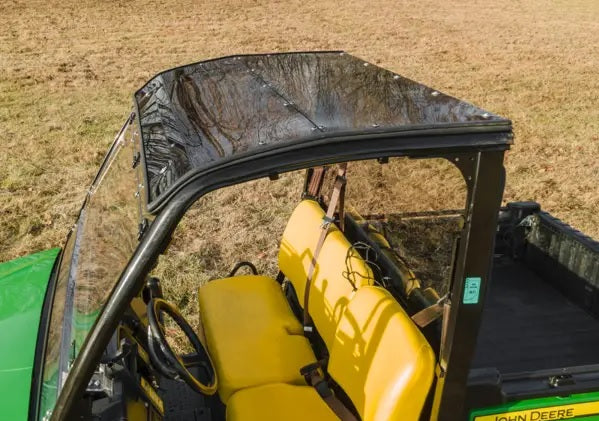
[135,52,511,206]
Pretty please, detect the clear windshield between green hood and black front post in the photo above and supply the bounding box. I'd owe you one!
[40,117,139,418]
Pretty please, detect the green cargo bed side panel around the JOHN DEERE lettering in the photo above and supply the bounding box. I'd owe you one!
[469,392,599,421]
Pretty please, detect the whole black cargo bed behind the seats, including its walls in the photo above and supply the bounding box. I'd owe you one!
[468,207,599,408]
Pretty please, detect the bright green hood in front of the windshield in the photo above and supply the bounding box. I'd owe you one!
[0,249,60,421]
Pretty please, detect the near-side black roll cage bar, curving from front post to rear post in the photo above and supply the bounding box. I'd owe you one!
[50,126,511,421]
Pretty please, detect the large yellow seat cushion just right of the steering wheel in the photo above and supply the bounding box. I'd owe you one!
[199,275,316,403]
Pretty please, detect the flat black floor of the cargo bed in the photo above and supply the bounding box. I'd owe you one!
[472,257,599,374]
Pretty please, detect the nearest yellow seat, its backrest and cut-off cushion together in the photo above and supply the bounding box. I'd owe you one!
[227,286,435,421]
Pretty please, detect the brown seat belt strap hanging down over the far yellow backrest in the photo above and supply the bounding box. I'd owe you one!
[304,163,347,334]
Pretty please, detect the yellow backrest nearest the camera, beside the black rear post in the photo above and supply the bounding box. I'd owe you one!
[328,286,435,421]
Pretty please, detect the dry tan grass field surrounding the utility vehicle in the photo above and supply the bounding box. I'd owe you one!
[0,0,599,352]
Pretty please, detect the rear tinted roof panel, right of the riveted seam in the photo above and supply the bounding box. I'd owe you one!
[246,53,499,132]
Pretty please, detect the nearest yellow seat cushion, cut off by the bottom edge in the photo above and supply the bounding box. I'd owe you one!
[227,384,339,421]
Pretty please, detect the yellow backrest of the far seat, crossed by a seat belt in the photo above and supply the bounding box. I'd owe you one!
[279,200,374,350]
